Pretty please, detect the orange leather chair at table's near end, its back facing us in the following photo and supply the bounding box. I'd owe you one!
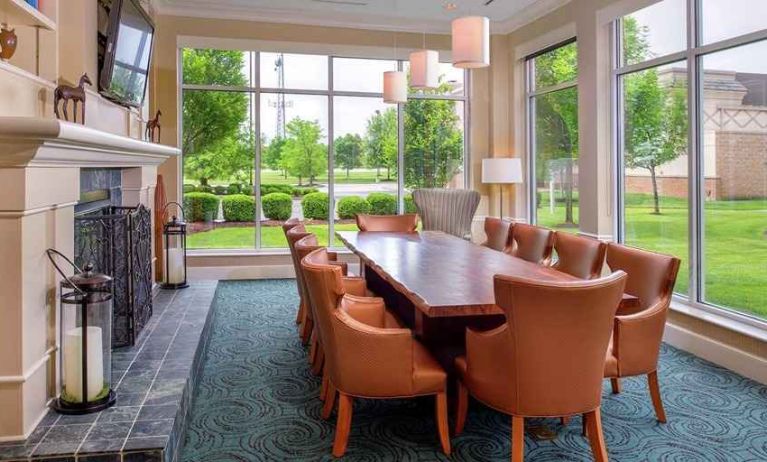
[456,271,626,461]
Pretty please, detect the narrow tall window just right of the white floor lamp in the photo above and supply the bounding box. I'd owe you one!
[527,42,578,231]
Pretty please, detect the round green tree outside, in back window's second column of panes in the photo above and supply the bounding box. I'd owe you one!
[282,117,328,185]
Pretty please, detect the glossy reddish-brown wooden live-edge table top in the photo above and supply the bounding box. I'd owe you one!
[336,231,576,317]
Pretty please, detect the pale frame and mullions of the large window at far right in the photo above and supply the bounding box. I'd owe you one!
[610,0,767,330]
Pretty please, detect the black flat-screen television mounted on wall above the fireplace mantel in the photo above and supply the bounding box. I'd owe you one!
[99,0,154,107]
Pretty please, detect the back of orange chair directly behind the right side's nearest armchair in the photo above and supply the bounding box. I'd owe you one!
[552,233,607,279]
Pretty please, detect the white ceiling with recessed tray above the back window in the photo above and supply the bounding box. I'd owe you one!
[153,0,569,33]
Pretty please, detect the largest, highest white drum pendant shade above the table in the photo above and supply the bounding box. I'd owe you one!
[453,16,490,69]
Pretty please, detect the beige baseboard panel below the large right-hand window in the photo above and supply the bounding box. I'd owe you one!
[663,324,767,385]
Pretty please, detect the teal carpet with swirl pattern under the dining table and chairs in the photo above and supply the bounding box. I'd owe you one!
[181,280,767,462]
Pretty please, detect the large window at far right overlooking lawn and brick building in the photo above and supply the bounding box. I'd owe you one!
[615,0,767,322]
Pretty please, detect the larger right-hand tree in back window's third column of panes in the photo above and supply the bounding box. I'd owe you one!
[365,107,398,180]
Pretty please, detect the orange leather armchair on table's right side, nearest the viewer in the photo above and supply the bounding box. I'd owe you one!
[604,243,680,422]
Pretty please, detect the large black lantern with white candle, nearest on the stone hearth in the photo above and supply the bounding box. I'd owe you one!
[47,249,116,414]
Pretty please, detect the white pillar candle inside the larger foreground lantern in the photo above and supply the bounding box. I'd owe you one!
[64,326,104,402]
